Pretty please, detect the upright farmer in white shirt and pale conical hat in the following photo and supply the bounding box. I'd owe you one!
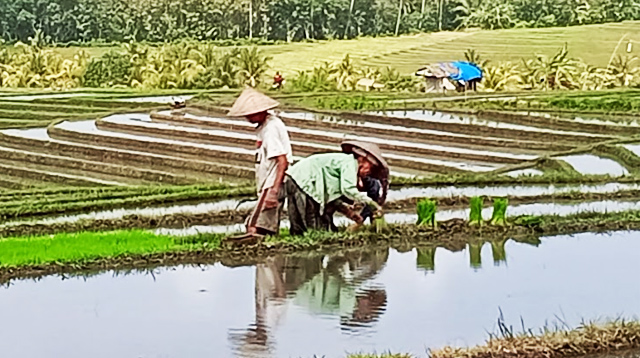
[228,87,293,241]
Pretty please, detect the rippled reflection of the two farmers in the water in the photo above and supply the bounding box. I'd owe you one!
[229,248,389,357]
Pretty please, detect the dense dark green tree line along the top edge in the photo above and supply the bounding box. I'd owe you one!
[0,0,640,44]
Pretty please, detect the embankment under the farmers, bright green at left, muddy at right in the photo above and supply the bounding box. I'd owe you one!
[0,211,640,281]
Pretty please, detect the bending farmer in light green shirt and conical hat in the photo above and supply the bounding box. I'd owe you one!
[285,141,389,235]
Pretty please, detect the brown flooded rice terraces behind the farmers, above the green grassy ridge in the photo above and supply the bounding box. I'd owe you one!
[0,92,640,189]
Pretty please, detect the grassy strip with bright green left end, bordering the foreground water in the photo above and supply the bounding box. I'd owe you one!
[8,204,640,268]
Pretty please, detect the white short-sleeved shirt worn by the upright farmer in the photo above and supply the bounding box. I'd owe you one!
[256,114,293,194]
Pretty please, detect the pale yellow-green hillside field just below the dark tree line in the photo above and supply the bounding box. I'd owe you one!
[51,21,640,76]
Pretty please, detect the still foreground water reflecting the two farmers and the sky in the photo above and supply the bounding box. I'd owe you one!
[0,232,640,358]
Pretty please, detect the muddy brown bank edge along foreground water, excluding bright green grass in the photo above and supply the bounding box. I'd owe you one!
[0,211,640,282]
